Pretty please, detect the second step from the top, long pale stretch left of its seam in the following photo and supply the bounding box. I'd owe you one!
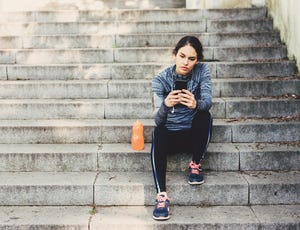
[0,20,206,36]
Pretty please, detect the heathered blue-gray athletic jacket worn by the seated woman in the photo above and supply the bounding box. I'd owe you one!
[152,63,212,131]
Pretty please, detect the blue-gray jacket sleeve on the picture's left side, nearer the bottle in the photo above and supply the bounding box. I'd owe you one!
[152,78,170,126]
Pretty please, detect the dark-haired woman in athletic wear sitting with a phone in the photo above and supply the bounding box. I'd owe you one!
[151,36,212,220]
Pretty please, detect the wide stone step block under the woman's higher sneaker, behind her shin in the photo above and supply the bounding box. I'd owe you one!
[95,172,248,205]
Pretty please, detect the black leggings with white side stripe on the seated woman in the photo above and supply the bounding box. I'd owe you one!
[151,111,212,192]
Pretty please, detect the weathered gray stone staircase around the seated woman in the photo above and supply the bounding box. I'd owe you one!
[0,2,300,229]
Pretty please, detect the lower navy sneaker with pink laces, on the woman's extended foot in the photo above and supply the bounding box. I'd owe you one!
[153,192,170,220]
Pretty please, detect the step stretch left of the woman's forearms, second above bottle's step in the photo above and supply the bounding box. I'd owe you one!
[0,98,152,120]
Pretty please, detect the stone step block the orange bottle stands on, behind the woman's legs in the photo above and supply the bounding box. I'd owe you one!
[98,143,239,172]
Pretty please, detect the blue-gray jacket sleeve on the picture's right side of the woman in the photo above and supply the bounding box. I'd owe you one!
[197,64,212,111]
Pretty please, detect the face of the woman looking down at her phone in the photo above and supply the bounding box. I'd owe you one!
[175,45,198,75]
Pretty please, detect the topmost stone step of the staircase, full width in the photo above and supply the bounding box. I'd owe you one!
[0,7,267,22]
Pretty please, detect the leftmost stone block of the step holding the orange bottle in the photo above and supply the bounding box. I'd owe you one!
[0,144,99,172]
